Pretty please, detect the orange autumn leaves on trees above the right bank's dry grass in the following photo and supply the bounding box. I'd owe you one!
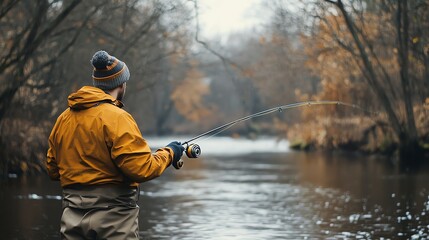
[301,13,390,119]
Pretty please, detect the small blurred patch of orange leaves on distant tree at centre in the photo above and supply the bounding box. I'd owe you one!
[171,67,212,122]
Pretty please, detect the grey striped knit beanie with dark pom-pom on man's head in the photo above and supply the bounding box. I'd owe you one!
[91,51,130,91]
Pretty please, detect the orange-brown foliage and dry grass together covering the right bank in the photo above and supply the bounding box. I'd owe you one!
[288,1,429,157]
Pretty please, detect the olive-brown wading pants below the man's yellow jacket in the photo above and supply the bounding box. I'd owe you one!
[61,185,139,240]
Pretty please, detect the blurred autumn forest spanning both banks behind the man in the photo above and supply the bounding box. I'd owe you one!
[0,0,429,176]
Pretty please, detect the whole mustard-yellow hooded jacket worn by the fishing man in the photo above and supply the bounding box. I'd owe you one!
[46,86,174,187]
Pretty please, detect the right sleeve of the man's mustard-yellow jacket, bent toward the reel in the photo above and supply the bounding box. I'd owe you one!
[110,112,174,182]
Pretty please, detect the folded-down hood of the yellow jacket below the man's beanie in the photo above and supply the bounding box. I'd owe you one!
[68,86,123,110]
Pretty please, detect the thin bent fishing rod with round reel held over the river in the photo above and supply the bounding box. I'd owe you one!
[172,100,374,169]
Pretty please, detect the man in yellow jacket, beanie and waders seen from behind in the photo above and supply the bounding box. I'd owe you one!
[46,51,184,239]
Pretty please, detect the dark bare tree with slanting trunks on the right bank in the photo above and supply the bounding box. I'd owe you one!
[308,0,421,161]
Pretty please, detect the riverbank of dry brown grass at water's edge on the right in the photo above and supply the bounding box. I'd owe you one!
[287,112,429,159]
